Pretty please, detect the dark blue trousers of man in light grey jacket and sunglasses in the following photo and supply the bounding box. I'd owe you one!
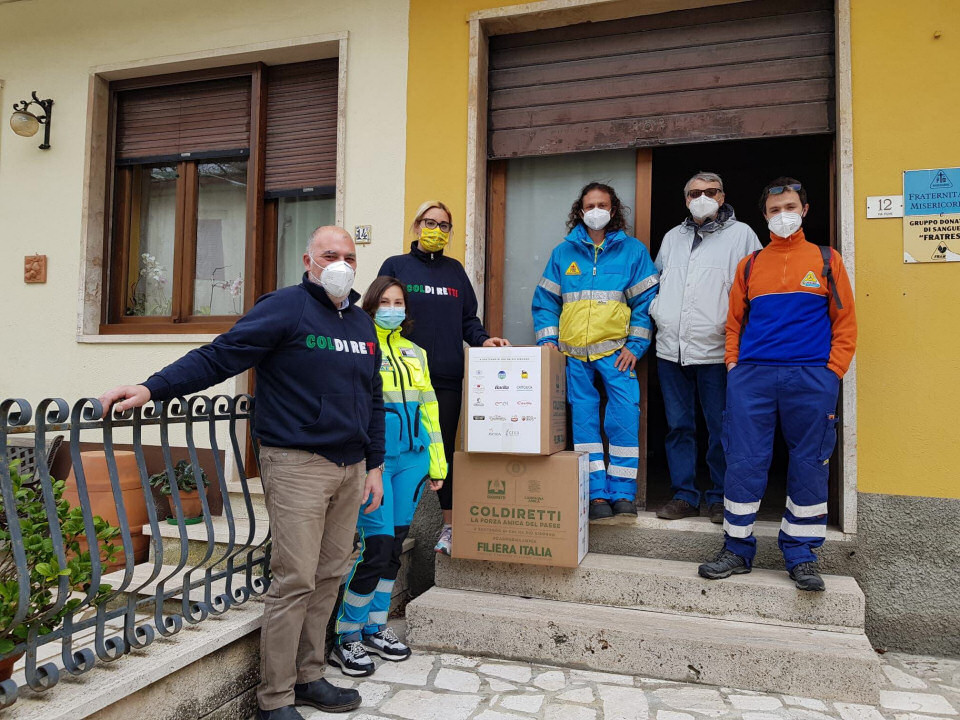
[657,358,727,507]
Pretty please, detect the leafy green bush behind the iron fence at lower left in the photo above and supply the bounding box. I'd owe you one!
[0,460,120,656]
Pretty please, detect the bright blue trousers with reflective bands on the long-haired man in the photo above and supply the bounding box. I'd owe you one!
[567,353,640,502]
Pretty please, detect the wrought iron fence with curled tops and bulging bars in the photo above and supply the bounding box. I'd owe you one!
[0,395,269,709]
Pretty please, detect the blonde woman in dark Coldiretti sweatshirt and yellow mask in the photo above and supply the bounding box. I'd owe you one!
[380,200,510,555]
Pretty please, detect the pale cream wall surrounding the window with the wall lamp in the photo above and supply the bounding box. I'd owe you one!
[0,0,409,403]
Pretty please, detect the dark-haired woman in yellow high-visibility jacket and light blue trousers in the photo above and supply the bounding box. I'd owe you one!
[330,277,447,676]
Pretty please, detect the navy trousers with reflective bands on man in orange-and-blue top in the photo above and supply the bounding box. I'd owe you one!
[723,365,840,570]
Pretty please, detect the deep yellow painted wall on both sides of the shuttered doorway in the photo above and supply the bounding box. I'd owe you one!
[398,0,960,498]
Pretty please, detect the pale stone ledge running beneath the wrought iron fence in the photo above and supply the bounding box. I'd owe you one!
[3,603,263,720]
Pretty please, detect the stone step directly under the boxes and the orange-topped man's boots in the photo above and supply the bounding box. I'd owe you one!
[436,553,864,633]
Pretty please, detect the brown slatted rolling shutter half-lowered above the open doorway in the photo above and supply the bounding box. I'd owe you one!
[488,0,834,158]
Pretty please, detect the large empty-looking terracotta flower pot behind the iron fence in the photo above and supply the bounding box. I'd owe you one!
[63,450,150,572]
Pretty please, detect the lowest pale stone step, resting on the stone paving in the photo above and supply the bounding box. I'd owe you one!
[407,588,880,704]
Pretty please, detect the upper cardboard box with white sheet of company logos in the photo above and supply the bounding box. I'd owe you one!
[462,346,567,455]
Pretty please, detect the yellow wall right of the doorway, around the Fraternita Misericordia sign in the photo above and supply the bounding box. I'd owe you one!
[851,0,960,498]
